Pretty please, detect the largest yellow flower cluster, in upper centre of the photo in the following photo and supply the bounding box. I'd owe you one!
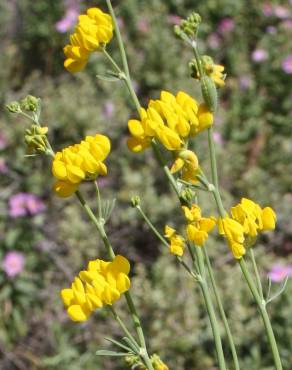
[128,91,213,152]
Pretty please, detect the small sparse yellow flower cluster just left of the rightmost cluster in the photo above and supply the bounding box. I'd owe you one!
[182,204,216,246]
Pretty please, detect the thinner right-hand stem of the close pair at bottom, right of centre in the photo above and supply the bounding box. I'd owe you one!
[203,246,240,370]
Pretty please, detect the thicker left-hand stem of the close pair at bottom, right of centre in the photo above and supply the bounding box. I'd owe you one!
[194,246,226,370]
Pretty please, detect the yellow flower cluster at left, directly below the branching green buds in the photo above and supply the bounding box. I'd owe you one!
[52,134,110,198]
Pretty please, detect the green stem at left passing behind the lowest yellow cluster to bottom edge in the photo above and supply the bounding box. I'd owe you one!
[75,190,154,370]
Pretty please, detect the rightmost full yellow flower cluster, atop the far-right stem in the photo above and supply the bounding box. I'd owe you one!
[218,198,277,259]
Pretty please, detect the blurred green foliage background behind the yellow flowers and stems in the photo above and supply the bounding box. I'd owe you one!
[0,0,292,370]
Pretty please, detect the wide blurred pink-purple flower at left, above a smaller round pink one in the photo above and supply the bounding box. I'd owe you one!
[9,193,46,218]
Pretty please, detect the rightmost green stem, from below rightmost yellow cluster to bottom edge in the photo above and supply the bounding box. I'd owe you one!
[238,258,283,370]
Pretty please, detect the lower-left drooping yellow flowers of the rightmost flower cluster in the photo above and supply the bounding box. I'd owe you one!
[218,216,246,259]
